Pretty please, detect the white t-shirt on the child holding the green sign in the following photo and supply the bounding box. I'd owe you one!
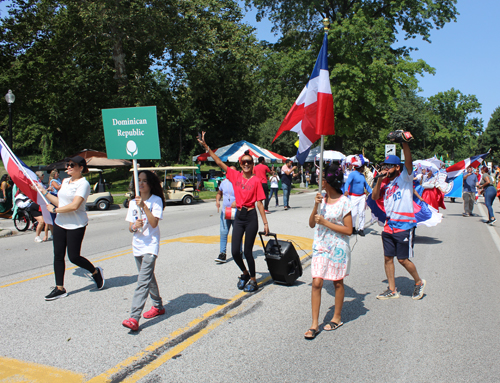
[125,194,163,257]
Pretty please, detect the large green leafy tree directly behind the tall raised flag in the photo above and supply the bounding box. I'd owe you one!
[246,0,457,146]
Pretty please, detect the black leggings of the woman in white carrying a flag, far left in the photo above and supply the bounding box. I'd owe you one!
[53,222,95,286]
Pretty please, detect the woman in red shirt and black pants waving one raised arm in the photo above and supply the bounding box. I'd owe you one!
[198,132,269,292]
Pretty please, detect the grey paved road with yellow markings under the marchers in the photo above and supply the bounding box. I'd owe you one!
[0,194,500,382]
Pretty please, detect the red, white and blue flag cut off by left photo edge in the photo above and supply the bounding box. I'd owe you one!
[0,136,53,225]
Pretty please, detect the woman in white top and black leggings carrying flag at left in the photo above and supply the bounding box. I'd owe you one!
[34,156,104,301]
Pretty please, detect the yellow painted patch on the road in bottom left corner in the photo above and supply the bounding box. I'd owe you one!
[0,357,84,383]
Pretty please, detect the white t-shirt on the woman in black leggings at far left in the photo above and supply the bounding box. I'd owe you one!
[56,177,90,230]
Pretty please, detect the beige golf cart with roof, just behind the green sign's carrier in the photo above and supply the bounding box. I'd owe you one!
[123,166,200,208]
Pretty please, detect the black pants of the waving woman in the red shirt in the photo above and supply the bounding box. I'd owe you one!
[231,208,259,277]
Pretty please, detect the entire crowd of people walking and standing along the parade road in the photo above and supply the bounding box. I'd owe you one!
[0,132,500,340]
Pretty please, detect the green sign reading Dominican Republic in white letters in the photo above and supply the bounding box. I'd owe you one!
[102,106,161,160]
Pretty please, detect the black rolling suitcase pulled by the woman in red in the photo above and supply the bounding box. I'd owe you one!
[259,232,302,285]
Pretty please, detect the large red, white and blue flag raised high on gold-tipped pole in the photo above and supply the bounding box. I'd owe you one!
[273,33,335,164]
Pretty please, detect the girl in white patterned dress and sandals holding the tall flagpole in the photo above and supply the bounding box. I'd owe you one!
[304,163,352,339]
